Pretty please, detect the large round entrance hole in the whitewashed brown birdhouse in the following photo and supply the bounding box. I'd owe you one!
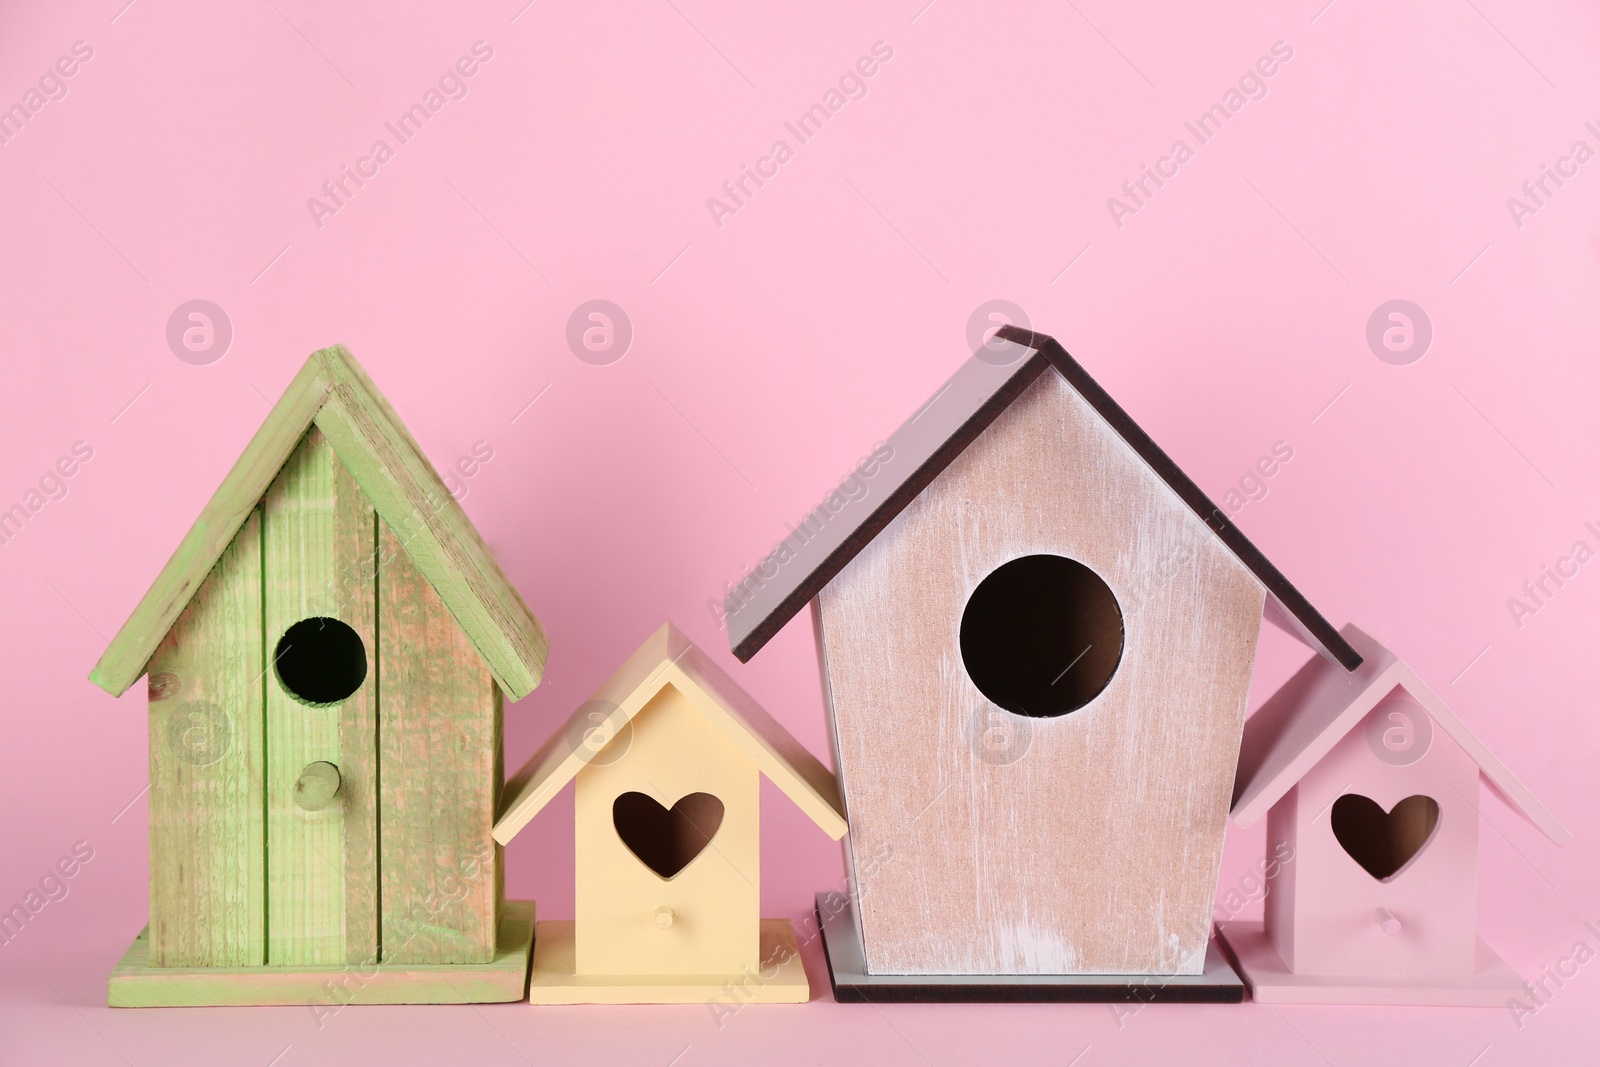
[962,555,1122,718]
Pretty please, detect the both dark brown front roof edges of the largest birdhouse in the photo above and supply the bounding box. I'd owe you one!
[728,326,1362,670]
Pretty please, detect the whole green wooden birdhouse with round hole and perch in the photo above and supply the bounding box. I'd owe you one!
[90,347,547,1006]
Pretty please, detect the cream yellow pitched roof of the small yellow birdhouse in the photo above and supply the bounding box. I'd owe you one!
[494,622,846,845]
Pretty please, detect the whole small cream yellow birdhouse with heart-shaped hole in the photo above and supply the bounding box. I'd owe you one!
[494,622,846,1005]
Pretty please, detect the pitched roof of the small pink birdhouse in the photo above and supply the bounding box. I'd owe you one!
[1232,624,1571,845]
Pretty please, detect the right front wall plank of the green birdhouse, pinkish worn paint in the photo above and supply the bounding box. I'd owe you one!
[378,520,502,963]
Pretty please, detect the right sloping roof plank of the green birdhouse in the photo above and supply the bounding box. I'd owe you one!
[317,347,549,699]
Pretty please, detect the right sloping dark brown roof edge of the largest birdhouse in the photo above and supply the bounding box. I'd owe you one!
[998,326,1362,670]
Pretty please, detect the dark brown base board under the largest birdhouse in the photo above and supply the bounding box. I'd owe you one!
[816,893,1245,1005]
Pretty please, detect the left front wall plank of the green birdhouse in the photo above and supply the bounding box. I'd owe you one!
[149,510,266,966]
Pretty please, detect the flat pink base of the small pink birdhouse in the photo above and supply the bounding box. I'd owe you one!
[1218,923,1525,1008]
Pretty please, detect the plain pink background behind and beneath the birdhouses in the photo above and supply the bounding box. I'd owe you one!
[0,0,1600,1067]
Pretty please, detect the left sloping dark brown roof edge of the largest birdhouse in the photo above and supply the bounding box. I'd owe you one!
[730,352,1050,662]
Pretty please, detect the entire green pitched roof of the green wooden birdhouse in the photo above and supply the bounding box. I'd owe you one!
[90,346,549,699]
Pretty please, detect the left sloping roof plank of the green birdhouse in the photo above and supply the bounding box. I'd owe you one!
[90,358,333,696]
